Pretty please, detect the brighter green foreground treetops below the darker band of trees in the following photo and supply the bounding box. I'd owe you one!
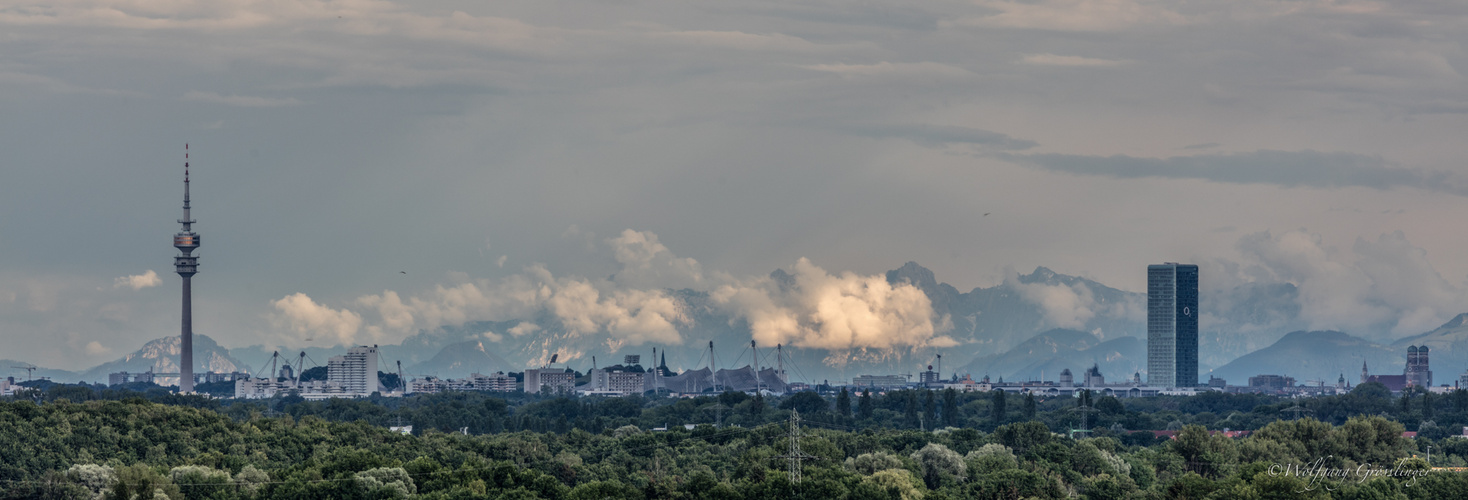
[0,396,1468,500]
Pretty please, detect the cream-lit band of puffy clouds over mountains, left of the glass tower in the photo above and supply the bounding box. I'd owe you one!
[275,230,956,356]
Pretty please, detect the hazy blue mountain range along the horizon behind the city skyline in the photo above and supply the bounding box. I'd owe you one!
[14,262,1468,384]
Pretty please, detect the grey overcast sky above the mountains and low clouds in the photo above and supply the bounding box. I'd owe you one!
[0,0,1468,368]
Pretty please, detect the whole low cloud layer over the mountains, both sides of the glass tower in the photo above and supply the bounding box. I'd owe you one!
[275,225,1468,369]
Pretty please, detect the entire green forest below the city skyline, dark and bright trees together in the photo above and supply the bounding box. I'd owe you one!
[0,384,1468,500]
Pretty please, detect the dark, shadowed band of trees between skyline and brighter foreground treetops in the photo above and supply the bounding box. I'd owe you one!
[11,383,1468,436]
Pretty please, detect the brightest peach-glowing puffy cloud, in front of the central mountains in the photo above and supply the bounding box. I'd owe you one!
[711,258,957,350]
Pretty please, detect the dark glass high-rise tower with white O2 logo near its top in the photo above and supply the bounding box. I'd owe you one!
[1147,262,1198,387]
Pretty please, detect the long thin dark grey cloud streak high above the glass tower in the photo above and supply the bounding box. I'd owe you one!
[998,150,1468,196]
